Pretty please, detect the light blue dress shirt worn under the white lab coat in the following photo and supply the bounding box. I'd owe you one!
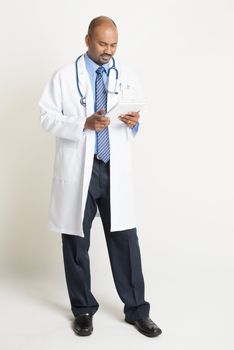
[84,52,139,154]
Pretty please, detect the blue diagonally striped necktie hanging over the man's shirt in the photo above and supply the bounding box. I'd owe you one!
[95,66,110,163]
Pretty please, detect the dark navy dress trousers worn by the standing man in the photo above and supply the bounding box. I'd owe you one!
[62,157,150,321]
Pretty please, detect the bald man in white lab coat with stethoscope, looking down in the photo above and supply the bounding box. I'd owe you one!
[39,16,161,337]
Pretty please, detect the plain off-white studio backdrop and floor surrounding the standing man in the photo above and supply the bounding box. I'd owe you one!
[0,0,234,350]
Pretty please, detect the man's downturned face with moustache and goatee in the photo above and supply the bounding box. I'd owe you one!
[85,23,118,65]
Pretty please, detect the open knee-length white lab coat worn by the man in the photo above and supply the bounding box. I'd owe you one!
[39,56,143,237]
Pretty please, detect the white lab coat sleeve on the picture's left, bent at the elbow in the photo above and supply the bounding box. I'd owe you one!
[39,72,86,141]
